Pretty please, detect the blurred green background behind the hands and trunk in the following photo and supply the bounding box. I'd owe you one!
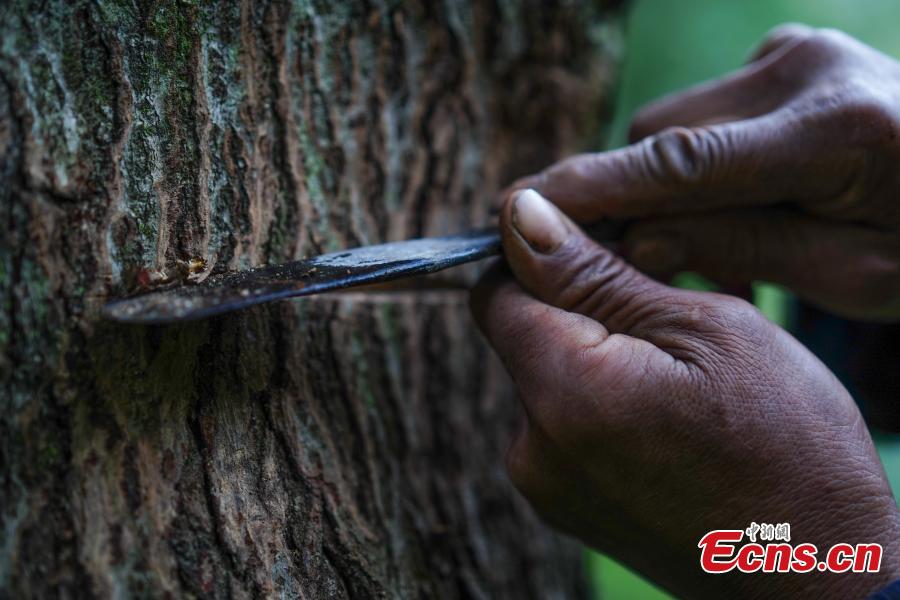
[587,0,900,600]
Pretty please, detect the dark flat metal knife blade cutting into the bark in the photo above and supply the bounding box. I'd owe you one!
[102,221,625,324]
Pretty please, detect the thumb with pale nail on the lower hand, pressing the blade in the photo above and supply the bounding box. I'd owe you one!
[500,189,678,337]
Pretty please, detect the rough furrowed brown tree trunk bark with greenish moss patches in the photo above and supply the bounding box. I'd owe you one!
[0,0,621,598]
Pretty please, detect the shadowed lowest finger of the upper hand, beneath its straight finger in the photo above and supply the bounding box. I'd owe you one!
[625,209,900,318]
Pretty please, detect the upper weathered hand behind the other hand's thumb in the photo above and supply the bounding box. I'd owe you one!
[502,25,900,319]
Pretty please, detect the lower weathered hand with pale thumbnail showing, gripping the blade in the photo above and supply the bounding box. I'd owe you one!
[473,191,900,598]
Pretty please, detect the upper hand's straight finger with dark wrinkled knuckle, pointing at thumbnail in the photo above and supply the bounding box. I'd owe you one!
[510,109,861,222]
